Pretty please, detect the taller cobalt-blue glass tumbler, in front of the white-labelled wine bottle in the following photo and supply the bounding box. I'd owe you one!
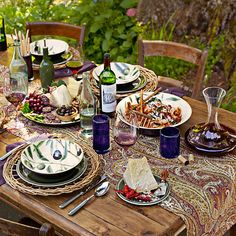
[93,114,110,154]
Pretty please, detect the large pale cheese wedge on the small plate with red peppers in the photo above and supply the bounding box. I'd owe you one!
[123,157,158,193]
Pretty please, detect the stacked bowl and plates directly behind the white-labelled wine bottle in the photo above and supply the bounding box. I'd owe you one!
[93,62,147,94]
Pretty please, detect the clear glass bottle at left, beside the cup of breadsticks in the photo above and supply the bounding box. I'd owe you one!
[9,40,28,95]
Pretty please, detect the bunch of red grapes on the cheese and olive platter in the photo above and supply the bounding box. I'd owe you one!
[27,93,49,114]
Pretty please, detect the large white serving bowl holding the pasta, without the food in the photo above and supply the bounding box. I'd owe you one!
[116,92,192,135]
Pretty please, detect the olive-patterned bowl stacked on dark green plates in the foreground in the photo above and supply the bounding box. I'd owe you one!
[16,139,87,187]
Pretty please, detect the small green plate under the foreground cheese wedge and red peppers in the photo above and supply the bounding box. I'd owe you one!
[116,175,170,206]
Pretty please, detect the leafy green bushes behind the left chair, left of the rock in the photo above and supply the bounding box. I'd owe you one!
[0,0,141,63]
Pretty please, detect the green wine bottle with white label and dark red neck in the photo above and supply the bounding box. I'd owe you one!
[99,53,116,117]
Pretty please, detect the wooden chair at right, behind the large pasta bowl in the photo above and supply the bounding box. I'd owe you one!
[138,39,208,99]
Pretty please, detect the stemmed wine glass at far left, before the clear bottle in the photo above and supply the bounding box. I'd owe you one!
[3,76,28,129]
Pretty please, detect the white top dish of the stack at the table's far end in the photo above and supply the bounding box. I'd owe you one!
[30,39,69,56]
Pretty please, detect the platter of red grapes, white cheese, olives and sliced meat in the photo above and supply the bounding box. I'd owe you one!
[21,78,80,126]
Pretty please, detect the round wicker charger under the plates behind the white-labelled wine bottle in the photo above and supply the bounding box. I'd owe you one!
[90,65,158,99]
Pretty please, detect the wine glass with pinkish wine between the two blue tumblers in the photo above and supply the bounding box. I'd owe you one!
[113,113,138,160]
